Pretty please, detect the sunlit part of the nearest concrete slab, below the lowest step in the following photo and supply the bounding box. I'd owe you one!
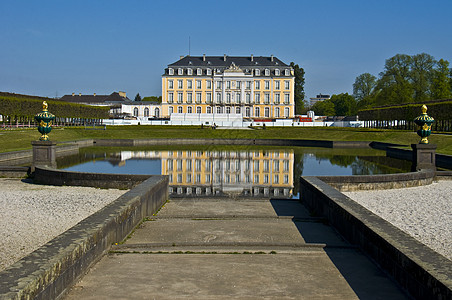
[66,252,358,300]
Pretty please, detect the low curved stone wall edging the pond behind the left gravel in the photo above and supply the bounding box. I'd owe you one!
[33,166,150,189]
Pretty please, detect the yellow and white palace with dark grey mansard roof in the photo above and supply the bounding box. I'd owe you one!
[161,55,295,120]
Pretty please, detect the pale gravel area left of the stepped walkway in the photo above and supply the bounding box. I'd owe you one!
[0,178,127,271]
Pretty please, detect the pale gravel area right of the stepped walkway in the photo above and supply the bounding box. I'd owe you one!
[343,181,452,260]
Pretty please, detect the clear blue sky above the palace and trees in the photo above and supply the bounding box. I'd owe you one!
[0,0,452,99]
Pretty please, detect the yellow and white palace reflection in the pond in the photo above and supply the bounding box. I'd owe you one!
[119,150,294,197]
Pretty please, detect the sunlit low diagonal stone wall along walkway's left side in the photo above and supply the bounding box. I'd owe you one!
[0,176,168,299]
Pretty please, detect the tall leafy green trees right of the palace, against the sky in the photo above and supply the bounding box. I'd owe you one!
[353,53,452,109]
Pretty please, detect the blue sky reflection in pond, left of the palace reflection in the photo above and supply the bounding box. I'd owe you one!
[64,159,162,175]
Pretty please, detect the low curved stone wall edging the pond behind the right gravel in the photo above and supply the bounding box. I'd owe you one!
[318,170,435,192]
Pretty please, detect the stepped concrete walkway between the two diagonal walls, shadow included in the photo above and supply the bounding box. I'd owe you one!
[66,198,405,299]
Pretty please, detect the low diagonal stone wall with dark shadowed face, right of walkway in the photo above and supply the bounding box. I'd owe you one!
[300,177,452,299]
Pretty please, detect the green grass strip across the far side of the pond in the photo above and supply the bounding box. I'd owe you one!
[0,125,452,154]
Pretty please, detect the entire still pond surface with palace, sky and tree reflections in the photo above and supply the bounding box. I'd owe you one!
[57,146,411,197]
